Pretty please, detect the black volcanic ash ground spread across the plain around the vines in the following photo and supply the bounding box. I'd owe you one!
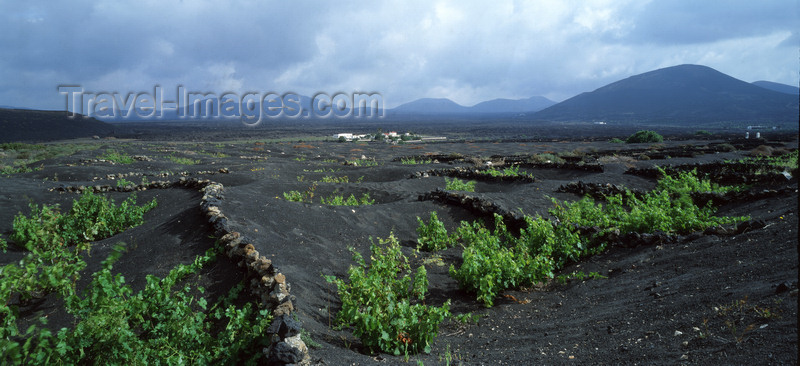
[0,121,798,365]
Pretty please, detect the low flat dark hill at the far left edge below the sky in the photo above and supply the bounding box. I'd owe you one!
[0,108,114,142]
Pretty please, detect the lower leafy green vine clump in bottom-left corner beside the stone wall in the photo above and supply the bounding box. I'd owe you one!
[0,246,271,365]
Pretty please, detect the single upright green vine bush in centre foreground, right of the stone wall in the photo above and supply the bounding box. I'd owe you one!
[325,234,450,356]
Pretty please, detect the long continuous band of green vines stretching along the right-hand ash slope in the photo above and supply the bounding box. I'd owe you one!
[446,171,749,307]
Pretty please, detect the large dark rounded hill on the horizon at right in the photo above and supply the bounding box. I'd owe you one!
[532,65,800,125]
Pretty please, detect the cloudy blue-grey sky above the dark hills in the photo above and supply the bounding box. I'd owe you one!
[0,0,800,109]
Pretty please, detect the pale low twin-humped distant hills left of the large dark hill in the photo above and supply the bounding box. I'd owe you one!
[390,96,556,115]
